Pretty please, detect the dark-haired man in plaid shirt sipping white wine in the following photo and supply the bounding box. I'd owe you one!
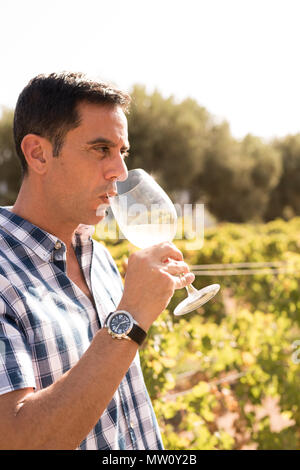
[0,73,194,450]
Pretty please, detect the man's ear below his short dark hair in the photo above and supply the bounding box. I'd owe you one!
[21,134,51,175]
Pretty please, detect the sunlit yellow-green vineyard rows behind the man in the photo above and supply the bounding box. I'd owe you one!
[95,218,300,450]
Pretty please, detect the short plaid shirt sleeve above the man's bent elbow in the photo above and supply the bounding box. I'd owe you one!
[0,296,36,395]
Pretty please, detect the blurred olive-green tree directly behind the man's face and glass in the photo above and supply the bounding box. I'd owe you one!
[128,85,211,192]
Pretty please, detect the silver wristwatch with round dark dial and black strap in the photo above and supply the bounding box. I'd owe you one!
[104,310,147,346]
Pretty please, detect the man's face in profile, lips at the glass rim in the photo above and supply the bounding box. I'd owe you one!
[46,103,129,225]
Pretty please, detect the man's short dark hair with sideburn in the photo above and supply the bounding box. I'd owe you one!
[14,72,130,176]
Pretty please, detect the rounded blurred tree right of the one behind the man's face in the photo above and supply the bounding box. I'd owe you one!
[192,126,282,222]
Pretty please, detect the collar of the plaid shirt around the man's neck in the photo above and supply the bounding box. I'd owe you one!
[0,206,95,261]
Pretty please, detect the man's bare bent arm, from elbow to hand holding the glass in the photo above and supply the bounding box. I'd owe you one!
[0,243,194,449]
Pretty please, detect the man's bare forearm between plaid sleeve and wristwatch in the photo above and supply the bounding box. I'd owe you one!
[10,329,138,449]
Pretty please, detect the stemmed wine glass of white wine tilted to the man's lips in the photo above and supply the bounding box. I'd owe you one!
[109,169,220,316]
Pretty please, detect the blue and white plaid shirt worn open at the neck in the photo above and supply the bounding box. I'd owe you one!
[0,207,162,450]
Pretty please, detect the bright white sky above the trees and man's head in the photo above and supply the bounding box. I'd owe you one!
[0,0,300,138]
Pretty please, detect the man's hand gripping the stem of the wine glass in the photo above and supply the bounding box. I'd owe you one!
[118,242,195,331]
